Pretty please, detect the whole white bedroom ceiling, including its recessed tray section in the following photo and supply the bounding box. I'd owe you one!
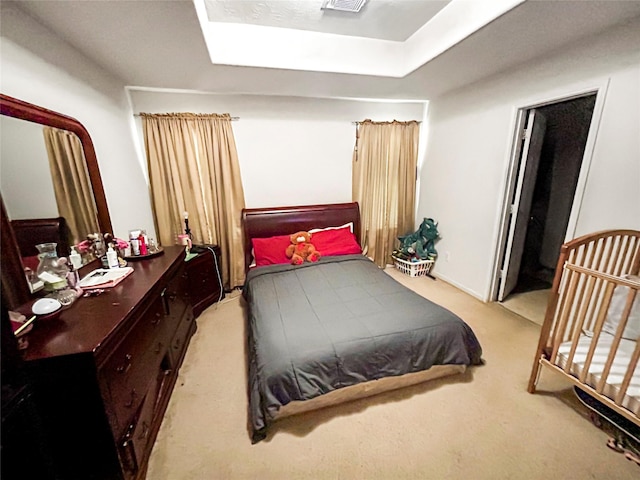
[5,0,640,100]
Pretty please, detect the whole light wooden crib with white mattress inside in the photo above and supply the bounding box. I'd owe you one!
[528,230,640,426]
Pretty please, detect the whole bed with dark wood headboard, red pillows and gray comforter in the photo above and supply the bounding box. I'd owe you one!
[243,203,482,443]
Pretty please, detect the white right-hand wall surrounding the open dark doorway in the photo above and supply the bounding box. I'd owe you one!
[418,21,640,300]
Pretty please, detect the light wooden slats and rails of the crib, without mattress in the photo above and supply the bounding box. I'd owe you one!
[528,230,640,422]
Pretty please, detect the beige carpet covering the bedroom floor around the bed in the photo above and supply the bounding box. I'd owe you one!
[147,270,640,480]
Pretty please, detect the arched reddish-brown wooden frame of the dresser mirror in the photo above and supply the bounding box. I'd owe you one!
[0,93,113,308]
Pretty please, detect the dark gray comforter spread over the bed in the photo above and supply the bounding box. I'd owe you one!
[243,255,482,443]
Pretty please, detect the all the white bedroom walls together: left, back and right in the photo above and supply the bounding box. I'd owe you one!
[0,2,640,299]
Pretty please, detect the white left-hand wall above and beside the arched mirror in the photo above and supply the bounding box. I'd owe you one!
[0,2,153,237]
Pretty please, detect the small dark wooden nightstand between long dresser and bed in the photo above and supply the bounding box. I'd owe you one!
[187,245,224,318]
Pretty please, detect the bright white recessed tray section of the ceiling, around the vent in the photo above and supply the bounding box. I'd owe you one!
[198,0,524,78]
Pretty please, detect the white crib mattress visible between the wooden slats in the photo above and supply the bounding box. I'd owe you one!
[558,332,640,416]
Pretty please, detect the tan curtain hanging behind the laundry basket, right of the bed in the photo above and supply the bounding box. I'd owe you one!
[352,120,420,267]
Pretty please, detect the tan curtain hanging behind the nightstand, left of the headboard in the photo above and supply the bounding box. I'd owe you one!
[141,113,245,289]
